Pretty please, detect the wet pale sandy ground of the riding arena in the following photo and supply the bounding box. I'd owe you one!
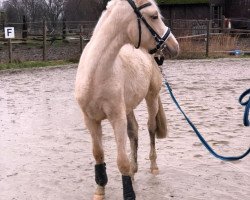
[0,59,250,200]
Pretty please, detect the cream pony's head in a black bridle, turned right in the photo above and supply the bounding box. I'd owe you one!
[126,0,179,56]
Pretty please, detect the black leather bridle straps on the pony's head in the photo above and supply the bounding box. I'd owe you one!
[127,0,171,54]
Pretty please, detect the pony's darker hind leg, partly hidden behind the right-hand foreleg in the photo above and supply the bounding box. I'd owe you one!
[127,111,138,179]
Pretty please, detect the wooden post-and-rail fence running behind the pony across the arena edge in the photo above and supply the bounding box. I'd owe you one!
[0,20,250,63]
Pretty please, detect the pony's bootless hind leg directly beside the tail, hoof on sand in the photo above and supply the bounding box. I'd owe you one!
[146,96,159,174]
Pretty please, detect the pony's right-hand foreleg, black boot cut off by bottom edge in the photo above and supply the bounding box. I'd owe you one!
[108,109,135,200]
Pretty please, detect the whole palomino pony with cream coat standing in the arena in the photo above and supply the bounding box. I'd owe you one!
[75,0,179,200]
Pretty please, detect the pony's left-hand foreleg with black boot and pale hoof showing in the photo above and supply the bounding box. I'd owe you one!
[84,116,108,200]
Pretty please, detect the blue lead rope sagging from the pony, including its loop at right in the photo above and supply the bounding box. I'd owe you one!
[165,80,250,161]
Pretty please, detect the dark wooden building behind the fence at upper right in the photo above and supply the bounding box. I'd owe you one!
[157,0,250,29]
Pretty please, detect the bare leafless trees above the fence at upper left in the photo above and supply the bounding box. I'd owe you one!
[3,0,108,22]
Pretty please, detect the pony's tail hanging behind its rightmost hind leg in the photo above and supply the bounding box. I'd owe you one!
[156,96,168,139]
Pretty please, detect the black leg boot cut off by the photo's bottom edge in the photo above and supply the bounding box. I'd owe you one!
[122,176,135,200]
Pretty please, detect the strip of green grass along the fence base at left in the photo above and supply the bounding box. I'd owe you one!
[0,60,75,70]
